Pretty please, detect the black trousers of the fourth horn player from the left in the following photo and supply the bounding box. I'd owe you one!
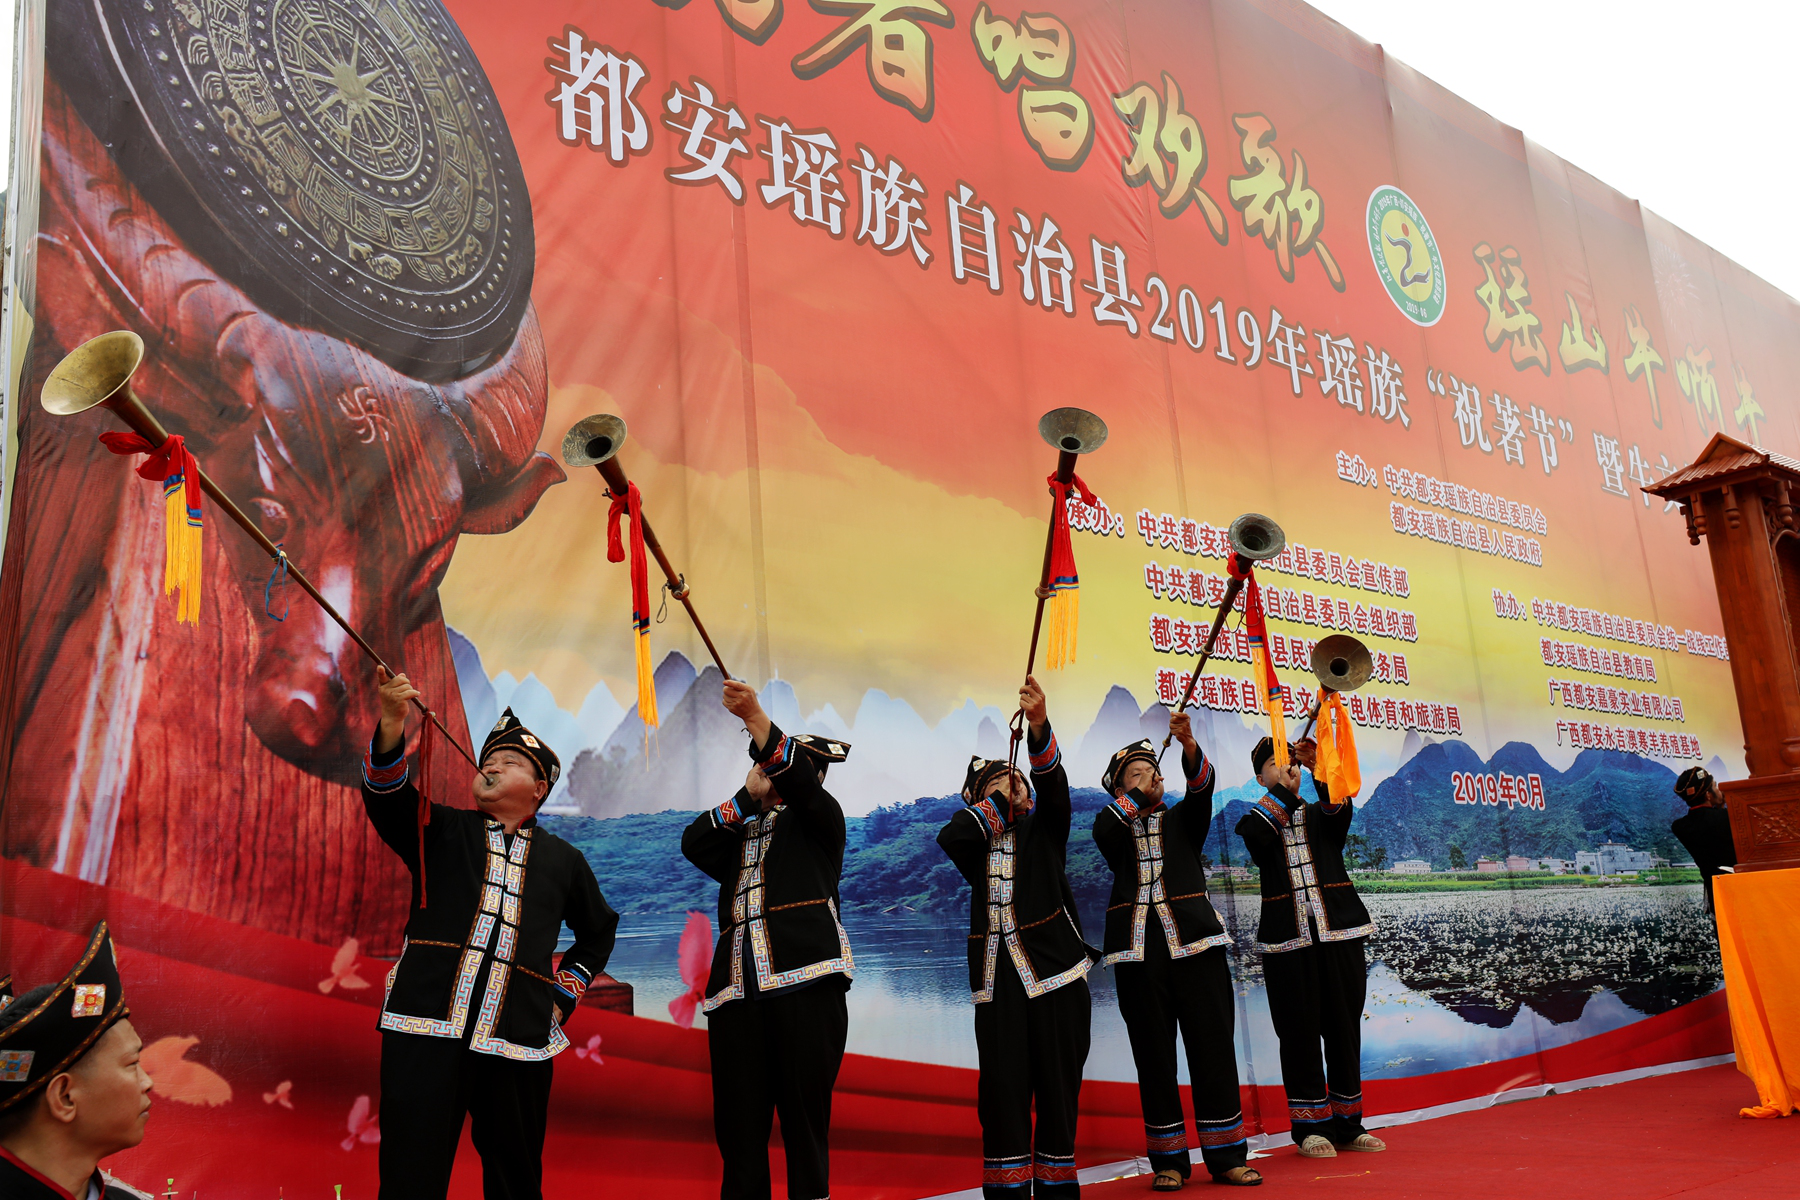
[1112,910,1249,1178]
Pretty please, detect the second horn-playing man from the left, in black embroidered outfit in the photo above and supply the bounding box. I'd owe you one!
[680,680,857,1200]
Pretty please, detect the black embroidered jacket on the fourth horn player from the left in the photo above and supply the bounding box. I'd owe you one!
[1094,750,1231,966]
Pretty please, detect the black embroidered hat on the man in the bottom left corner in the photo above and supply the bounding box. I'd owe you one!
[0,921,131,1114]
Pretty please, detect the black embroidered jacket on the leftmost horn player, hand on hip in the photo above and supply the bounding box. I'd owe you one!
[362,747,619,1061]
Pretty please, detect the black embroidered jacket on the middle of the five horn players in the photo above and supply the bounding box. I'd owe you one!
[938,732,1100,1004]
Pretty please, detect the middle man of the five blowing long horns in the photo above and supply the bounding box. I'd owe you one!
[938,676,1100,1200]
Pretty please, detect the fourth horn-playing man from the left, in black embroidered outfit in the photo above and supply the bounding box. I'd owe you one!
[1094,712,1262,1191]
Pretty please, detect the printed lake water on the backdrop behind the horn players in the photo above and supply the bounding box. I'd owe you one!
[549,827,1721,1083]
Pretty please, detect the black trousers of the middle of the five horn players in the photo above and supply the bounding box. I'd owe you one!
[976,946,1093,1200]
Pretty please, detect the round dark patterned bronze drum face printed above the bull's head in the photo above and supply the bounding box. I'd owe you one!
[47,0,529,381]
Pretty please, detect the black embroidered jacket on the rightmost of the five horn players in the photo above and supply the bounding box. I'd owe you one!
[1237,781,1375,954]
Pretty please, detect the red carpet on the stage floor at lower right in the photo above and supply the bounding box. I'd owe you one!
[1082,1065,1800,1200]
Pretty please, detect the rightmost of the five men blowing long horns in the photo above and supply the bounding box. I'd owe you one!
[1237,727,1388,1159]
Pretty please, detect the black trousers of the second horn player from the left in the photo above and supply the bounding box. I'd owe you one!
[706,975,850,1200]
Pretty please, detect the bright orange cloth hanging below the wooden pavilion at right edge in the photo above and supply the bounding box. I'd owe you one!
[1712,871,1800,1117]
